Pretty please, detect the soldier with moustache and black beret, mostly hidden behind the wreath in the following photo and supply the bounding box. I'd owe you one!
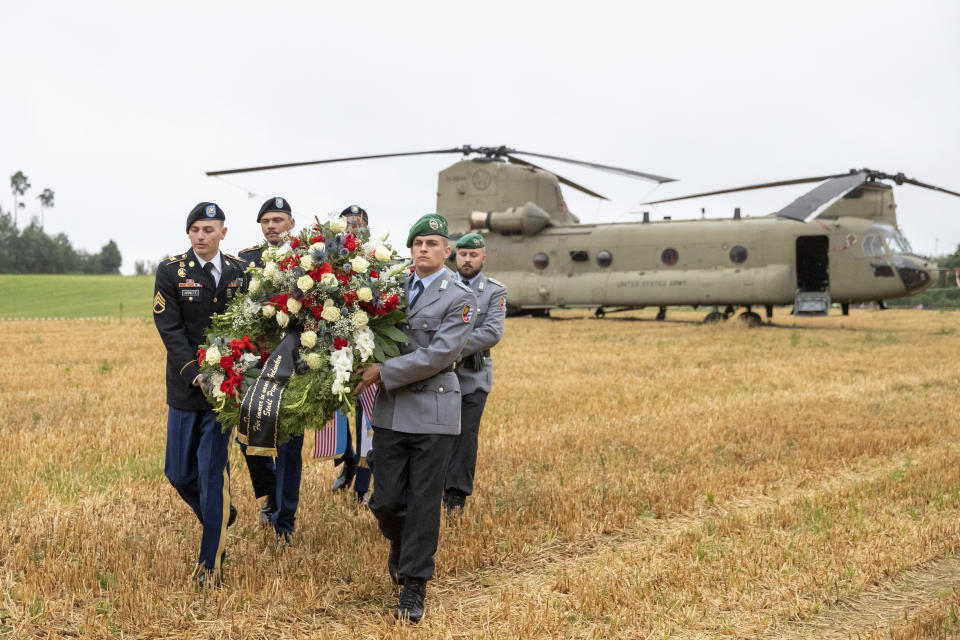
[240,196,303,545]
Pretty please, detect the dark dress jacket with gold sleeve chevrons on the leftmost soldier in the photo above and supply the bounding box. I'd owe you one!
[153,249,247,411]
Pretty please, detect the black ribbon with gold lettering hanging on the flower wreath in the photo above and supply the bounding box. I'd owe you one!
[237,331,300,457]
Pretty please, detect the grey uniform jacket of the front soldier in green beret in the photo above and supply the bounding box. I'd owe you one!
[371,267,477,435]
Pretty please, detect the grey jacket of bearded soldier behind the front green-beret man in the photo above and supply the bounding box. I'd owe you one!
[457,272,507,394]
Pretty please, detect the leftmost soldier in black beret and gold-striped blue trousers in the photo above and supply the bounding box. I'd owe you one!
[153,202,246,587]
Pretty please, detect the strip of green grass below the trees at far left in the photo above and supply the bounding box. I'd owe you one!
[0,275,153,318]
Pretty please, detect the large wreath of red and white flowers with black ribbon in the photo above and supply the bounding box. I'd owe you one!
[197,218,408,455]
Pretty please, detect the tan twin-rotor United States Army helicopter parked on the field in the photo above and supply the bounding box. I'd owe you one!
[207,146,960,324]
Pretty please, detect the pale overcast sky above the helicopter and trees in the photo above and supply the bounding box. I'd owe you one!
[0,0,960,273]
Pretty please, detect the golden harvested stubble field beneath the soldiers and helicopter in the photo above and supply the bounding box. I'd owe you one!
[0,310,960,638]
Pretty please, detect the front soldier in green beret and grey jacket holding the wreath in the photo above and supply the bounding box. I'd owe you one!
[357,214,477,622]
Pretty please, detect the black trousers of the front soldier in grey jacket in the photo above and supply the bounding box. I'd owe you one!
[369,426,456,580]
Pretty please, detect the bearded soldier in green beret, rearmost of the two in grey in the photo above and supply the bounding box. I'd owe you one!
[443,233,507,514]
